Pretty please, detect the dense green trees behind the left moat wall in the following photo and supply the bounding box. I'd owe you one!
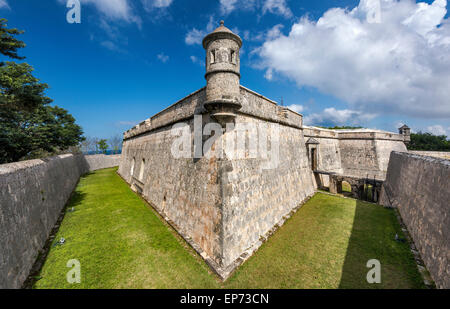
[0,19,84,164]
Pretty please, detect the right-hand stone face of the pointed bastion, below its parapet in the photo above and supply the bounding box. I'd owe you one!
[220,115,315,266]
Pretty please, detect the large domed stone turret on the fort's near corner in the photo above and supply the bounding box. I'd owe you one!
[203,21,242,125]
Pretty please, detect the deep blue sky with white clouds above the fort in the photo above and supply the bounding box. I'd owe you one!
[0,0,450,138]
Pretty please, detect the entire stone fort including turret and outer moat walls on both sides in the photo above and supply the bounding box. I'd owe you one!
[0,23,450,289]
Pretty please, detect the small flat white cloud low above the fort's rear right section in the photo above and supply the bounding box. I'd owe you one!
[304,107,376,126]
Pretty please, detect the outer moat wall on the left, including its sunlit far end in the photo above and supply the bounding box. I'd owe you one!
[0,154,119,288]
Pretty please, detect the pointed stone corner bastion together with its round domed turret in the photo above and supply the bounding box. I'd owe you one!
[118,24,315,279]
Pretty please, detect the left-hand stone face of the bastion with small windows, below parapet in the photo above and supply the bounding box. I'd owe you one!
[119,115,222,263]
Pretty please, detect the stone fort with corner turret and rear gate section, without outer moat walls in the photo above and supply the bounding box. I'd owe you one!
[118,22,409,278]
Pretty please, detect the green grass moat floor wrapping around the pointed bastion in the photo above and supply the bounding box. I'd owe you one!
[34,169,423,288]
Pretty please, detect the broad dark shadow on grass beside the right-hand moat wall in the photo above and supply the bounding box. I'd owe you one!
[339,201,424,289]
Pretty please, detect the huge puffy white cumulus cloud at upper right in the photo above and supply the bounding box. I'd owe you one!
[256,0,450,118]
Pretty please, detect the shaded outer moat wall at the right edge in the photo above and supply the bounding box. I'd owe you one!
[380,152,450,289]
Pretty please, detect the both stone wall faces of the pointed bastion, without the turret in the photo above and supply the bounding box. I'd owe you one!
[119,87,315,278]
